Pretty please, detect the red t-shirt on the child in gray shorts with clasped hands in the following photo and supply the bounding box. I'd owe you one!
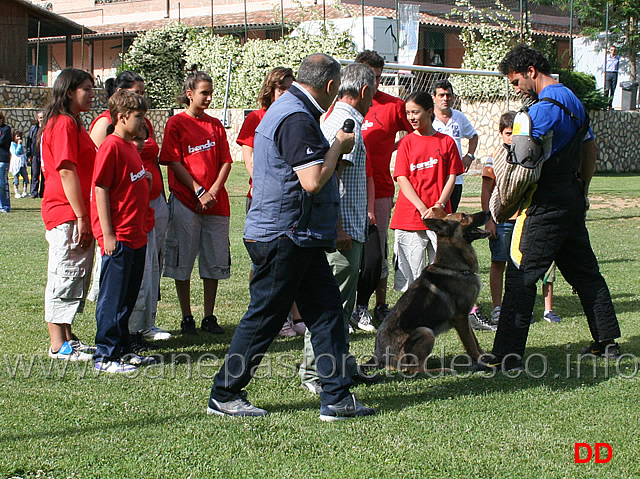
[160,112,232,216]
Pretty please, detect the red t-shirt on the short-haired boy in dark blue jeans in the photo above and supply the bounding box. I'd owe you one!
[91,135,154,249]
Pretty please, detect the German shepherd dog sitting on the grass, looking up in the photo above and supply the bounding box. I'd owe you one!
[362,211,490,373]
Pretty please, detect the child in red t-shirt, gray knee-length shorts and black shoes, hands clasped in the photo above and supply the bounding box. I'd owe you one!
[160,71,232,334]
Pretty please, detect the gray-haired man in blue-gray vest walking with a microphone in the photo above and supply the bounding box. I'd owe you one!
[207,53,375,421]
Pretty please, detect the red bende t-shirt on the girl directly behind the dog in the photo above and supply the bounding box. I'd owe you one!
[390,132,464,231]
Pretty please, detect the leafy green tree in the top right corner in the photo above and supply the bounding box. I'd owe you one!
[532,0,640,79]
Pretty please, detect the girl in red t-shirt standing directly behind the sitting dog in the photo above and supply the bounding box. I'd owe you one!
[390,92,464,291]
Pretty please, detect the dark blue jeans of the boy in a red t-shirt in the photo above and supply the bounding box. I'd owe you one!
[93,241,147,361]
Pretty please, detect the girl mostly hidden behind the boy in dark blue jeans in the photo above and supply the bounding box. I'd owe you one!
[89,70,171,346]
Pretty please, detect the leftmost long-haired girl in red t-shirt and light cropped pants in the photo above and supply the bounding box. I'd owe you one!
[41,68,96,361]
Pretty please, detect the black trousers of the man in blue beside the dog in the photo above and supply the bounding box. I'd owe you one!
[493,180,620,358]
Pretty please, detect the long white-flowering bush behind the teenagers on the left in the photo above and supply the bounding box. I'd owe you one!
[122,23,355,108]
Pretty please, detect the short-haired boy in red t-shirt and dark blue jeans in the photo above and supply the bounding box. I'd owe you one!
[91,90,154,373]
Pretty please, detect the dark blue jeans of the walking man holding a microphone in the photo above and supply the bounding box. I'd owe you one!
[211,236,351,404]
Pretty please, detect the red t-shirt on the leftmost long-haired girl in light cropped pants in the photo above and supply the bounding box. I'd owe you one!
[42,115,97,230]
